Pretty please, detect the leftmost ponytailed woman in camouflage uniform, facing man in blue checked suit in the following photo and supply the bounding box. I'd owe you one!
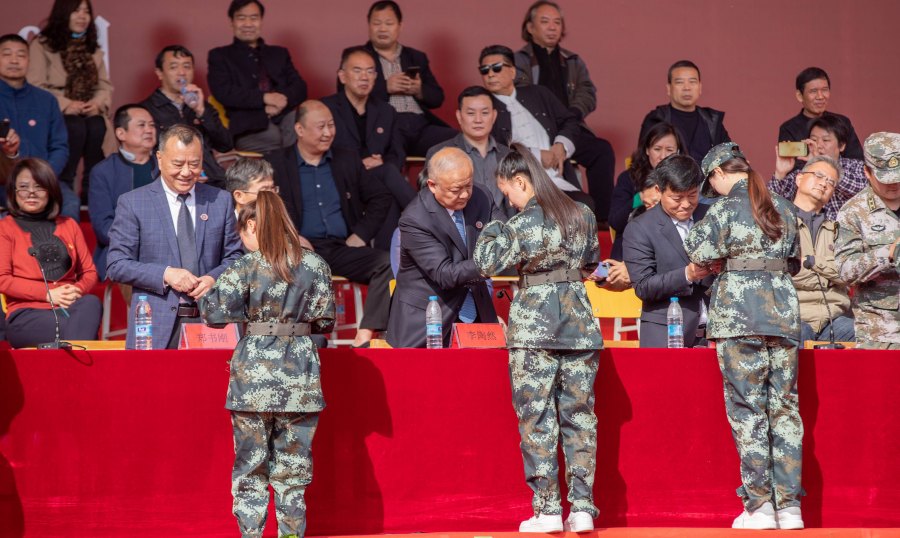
[199,192,334,537]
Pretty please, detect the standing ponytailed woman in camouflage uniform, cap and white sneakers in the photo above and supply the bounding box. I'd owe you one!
[684,142,803,529]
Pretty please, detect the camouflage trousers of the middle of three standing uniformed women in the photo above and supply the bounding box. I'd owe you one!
[509,348,600,517]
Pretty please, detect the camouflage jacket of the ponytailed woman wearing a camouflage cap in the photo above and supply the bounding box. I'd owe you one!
[684,179,800,340]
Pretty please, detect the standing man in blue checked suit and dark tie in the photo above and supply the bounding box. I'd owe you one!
[106,124,241,349]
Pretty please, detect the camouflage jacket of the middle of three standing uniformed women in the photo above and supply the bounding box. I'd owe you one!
[474,198,603,349]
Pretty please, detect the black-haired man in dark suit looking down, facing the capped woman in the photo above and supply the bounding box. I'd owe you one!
[624,154,715,347]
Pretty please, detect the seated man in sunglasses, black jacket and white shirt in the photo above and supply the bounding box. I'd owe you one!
[478,45,594,211]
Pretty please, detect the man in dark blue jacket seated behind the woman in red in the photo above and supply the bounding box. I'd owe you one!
[0,34,80,222]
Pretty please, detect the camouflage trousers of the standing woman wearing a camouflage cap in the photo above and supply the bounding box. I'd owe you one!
[716,336,805,512]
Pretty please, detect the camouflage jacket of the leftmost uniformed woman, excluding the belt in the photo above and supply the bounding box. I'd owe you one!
[199,250,334,413]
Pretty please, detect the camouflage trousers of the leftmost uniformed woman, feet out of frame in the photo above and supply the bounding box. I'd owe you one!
[231,411,319,538]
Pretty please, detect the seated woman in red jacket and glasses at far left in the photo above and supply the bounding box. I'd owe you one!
[0,159,103,348]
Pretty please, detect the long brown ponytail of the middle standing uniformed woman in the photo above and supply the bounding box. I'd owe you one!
[497,142,590,241]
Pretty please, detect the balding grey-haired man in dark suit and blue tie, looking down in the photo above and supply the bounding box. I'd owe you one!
[387,148,505,347]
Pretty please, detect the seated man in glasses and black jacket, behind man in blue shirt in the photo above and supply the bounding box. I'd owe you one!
[322,47,416,249]
